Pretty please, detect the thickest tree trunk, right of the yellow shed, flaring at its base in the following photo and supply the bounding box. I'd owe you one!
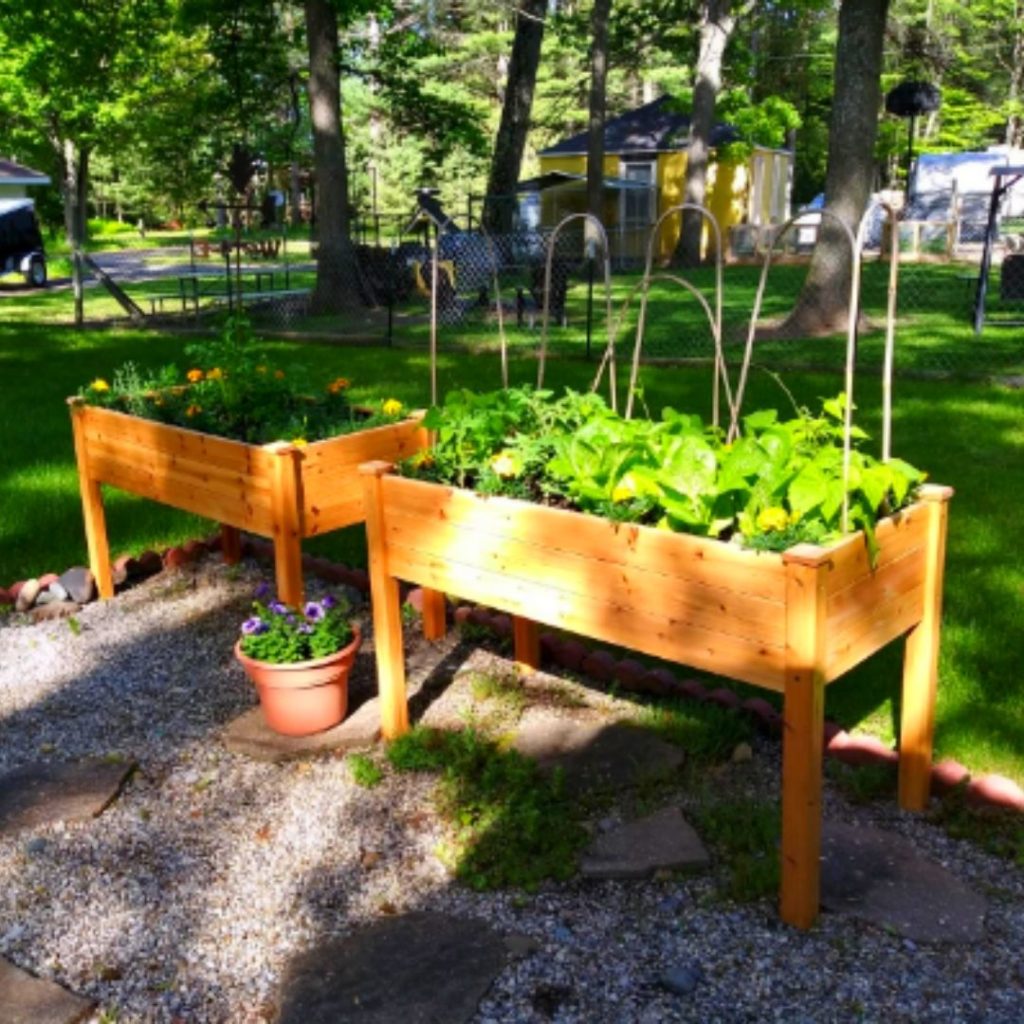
[772,0,889,337]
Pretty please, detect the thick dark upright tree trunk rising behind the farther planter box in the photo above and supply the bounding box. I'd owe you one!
[305,0,357,312]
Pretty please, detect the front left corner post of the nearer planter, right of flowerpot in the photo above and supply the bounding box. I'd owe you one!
[359,462,407,739]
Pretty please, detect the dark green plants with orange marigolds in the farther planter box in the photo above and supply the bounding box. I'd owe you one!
[79,315,404,444]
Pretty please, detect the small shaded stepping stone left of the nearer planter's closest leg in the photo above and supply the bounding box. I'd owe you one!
[580,807,710,879]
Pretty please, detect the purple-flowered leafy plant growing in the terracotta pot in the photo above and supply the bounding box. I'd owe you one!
[242,592,352,665]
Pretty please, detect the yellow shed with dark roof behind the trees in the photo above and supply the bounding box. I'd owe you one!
[532,96,793,259]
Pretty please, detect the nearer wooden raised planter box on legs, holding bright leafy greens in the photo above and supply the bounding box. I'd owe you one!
[360,463,952,928]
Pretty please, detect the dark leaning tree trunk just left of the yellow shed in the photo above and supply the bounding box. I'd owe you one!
[483,0,548,234]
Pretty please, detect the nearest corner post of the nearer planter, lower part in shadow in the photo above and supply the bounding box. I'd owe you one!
[780,544,827,928]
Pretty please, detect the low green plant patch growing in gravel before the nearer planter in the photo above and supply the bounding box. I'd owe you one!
[387,727,586,889]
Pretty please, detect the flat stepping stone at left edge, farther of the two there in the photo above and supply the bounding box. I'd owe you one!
[0,761,135,836]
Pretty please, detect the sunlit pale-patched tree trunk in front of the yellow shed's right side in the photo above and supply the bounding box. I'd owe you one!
[678,0,736,266]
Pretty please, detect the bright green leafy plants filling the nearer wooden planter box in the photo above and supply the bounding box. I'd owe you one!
[403,388,925,551]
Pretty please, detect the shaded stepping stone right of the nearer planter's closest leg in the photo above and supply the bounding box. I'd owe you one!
[821,822,986,944]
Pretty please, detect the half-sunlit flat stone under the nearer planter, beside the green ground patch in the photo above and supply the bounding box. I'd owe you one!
[513,708,684,796]
